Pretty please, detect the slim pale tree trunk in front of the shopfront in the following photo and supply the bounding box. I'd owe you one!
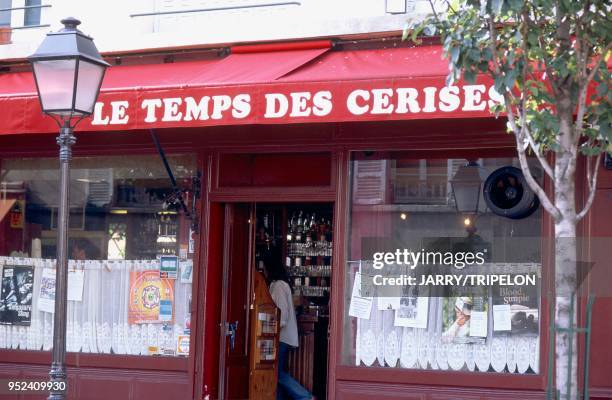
[555,148,578,400]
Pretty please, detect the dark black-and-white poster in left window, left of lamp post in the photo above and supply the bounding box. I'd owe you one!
[0,265,34,325]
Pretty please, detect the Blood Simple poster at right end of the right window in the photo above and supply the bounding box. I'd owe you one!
[492,285,540,335]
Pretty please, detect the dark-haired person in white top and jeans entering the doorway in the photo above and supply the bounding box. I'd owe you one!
[264,257,314,400]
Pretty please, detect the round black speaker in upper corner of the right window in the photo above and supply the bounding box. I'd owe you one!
[483,166,540,219]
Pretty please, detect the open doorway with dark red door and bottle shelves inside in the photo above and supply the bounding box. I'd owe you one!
[219,203,333,399]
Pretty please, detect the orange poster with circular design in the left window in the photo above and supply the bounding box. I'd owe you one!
[128,270,174,324]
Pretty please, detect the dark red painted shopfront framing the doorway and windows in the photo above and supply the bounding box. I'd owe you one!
[0,43,612,400]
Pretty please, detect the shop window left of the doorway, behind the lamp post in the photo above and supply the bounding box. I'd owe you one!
[0,155,196,356]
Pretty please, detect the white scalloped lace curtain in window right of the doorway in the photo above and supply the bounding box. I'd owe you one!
[348,264,541,374]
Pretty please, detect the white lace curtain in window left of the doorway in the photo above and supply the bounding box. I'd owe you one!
[0,257,191,355]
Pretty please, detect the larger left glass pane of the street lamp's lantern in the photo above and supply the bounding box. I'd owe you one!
[32,59,76,115]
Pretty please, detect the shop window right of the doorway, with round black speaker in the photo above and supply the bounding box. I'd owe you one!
[342,152,542,374]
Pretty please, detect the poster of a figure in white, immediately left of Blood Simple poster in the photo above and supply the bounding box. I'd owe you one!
[442,288,489,343]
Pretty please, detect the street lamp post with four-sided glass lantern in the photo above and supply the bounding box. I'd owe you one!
[28,18,109,400]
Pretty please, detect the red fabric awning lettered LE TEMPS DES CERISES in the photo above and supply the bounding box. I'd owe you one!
[0,41,500,134]
